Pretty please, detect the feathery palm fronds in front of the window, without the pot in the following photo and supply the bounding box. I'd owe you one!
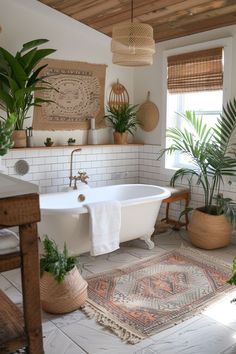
[159,99,236,221]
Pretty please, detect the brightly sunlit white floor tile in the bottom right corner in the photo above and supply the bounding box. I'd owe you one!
[135,316,236,354]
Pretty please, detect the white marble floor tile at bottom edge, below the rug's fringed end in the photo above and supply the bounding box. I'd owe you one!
[61,319,154,354]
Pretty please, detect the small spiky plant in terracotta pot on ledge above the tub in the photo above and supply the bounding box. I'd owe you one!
[105,104,140,144]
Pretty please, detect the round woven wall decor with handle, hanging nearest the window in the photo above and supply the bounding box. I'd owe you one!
[137,91,159,132]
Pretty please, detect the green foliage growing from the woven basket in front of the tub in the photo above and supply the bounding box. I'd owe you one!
[40,236,75,283]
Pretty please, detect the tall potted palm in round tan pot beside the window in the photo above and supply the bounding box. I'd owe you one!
[159,99,236,249]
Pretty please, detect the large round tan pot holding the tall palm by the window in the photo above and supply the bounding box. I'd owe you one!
[188,209,232,250]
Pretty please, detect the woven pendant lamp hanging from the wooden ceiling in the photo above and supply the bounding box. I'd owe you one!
[111,0,155,66]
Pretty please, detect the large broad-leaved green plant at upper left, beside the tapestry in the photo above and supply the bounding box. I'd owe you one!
[0,39,55,130]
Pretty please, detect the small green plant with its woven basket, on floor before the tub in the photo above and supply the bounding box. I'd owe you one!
[40,236,88,314]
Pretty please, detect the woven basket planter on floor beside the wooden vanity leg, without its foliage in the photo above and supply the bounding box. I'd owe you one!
[40,267,88,314]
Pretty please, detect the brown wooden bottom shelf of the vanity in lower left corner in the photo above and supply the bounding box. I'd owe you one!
[0,290,27,353]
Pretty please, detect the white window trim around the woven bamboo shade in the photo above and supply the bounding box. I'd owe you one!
[161,37,232,174]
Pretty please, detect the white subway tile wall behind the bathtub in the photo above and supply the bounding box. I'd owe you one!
[2,144,236,218]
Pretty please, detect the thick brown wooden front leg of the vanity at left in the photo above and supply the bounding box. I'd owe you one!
[19,223,44,354]
